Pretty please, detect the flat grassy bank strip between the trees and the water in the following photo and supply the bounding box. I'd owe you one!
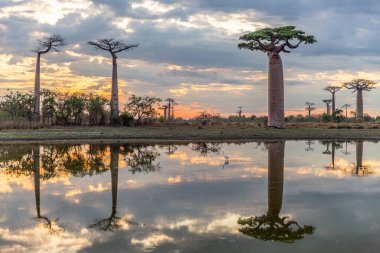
[0,125,380,143]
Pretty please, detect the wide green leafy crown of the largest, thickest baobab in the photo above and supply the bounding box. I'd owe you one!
[238,26,317,53]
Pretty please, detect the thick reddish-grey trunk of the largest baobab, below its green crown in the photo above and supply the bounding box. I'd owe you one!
[268,52,285,128]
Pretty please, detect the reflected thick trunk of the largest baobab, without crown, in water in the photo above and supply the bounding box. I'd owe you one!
[267,141,285,217]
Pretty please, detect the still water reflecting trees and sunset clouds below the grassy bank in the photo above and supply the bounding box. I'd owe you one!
[0,141,380,253]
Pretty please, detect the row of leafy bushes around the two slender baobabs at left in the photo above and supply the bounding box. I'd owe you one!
[0,89,161,126]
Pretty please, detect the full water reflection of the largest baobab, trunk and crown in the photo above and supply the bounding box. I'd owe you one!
[238,142,315,243]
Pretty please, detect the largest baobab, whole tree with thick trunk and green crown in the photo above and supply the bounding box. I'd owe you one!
[238,26,317,128]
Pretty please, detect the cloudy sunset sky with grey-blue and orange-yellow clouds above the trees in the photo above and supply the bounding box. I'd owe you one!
[0,0,380,118]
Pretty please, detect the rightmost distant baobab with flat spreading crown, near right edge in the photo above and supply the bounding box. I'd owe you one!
[343,79,376,119]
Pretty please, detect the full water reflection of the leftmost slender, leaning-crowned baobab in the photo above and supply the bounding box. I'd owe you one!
[32,145,63,234]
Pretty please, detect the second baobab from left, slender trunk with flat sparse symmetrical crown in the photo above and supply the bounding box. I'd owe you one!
[87,38,139,126]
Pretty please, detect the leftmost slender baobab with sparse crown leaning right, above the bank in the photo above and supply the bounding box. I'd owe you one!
[32,34,66,122]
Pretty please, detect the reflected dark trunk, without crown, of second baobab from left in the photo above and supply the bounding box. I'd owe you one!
[110,145,120,217]
